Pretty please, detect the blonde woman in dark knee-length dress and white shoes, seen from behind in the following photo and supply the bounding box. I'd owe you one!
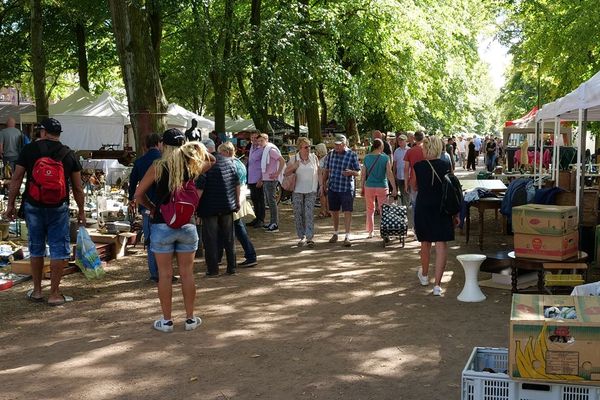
[415,136,458,296]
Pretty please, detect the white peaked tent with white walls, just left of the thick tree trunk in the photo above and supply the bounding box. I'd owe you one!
[54,92,130,150]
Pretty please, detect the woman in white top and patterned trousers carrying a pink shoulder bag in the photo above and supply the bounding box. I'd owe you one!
[284,136,319,247]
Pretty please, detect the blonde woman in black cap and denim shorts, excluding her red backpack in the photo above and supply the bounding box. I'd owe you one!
[135,129,214,332]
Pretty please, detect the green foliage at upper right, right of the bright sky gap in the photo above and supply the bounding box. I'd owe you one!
[499,0,600,119]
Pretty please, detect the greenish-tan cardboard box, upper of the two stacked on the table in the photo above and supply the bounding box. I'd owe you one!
[512,204,578,236]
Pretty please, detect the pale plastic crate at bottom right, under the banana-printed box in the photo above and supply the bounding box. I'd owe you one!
[461,347,600,400]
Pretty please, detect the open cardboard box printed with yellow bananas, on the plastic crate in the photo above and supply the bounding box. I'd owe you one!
[508,294,600,385]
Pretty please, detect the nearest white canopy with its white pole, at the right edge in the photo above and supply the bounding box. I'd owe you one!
[537,71,600,219]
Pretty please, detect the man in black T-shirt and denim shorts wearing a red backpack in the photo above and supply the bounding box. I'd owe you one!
[5,118,85,306]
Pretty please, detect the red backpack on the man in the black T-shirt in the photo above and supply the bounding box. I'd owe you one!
[27,143,71,205]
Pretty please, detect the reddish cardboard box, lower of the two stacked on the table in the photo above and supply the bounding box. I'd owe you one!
[514,231,579,261]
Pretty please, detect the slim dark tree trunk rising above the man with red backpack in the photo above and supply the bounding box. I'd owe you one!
[31,0,49,122]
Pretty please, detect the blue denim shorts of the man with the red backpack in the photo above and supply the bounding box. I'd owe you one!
[24,201,71,260]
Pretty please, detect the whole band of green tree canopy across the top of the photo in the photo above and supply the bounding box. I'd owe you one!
[0,0,600,141]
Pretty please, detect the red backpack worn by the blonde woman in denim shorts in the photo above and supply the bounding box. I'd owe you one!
[160,180,200,229]
